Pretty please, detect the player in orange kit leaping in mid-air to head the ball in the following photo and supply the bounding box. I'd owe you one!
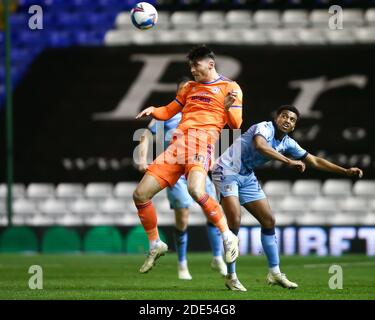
[133,45,242,273]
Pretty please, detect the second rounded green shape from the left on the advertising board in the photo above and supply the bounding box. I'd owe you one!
[42,227,81,253]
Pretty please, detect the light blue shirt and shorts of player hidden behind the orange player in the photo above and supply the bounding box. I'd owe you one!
[148,112,216,209]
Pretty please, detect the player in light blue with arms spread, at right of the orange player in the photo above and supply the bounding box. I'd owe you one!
[212,105,363,291]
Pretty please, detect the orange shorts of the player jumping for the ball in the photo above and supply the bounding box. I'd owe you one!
[146,130,214,188]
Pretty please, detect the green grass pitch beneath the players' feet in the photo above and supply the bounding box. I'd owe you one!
[0,253,375,300]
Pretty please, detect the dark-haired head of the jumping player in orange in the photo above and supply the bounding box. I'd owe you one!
[187,45,216,82]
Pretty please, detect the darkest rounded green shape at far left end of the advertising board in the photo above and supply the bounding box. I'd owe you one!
[0,227,38,253]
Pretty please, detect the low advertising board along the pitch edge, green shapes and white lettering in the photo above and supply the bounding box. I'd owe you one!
[0,225,375,256]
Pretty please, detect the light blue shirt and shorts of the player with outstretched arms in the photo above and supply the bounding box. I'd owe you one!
[212,121,308,205]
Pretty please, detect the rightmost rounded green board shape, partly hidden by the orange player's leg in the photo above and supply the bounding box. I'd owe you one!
[123,226,167,254]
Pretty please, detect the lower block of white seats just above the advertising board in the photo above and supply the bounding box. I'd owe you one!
[0,179,375,226]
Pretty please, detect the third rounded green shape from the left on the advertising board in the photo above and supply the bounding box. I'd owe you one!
[83,226,121,253]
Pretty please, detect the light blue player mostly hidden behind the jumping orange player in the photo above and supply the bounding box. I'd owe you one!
[138,78,227,280]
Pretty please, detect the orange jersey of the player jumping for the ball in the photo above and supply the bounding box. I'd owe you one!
[175,76,242,134]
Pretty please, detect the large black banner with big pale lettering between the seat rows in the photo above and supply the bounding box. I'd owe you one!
[0,45,375,183]
